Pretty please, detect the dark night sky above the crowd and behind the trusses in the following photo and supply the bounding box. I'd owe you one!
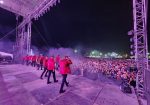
[0,0,149,53]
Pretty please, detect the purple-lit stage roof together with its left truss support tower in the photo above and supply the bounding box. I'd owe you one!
[0,0,60,59]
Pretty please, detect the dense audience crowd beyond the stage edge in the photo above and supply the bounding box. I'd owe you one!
[72,58,137,87]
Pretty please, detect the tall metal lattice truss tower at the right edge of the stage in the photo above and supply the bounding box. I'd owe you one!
[133,0,148,96]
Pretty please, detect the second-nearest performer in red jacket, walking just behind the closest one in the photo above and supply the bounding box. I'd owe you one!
[47,56,58,84]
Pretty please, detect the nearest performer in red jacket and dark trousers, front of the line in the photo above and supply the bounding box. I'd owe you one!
[59,56,72,93]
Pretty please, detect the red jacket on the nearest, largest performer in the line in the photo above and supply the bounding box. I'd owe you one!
[59,59,72,74]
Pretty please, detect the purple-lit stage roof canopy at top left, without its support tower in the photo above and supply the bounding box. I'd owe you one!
[0,0,57,17]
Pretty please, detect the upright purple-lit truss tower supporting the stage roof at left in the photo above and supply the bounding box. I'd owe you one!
[14,18,31,61]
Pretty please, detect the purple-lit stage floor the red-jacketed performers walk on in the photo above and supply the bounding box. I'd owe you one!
[0,65,139,105]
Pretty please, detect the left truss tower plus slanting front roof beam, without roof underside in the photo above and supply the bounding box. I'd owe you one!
[16,0,60,56]
